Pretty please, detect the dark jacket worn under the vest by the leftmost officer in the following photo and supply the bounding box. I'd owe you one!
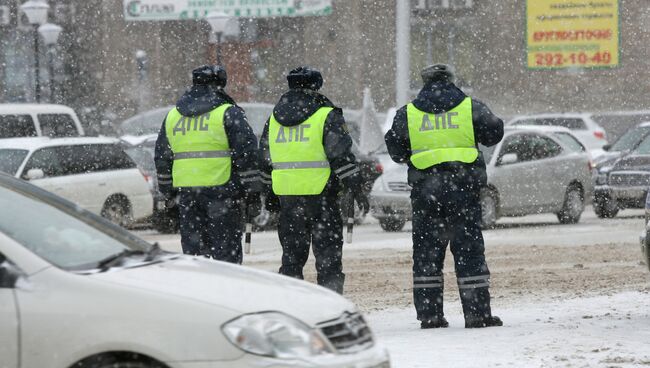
[155,85,260,198]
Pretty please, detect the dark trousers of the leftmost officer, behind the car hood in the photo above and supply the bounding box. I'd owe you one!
[179,189,242,264]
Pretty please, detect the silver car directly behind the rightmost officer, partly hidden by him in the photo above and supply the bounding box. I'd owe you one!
[371,126,593,231]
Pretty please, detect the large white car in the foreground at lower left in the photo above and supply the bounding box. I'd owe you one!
[0,174,390,368]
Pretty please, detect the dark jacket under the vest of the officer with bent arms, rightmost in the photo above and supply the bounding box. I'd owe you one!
[384,82,503,187]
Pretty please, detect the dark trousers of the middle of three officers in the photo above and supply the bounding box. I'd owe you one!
[278,195,345,294]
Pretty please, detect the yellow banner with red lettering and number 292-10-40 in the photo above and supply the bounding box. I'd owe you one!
[526,0,619,69]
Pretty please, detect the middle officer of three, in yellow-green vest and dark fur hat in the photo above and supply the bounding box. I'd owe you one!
[260,67,369,293]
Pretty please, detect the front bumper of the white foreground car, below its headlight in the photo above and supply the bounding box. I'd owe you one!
[167,346,390,368]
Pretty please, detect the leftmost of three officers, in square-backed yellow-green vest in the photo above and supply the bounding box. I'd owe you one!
[155,65,261,263]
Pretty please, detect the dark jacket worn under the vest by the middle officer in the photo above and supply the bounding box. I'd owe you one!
[260,89,362,195]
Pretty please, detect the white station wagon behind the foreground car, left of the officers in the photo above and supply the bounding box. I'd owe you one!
[0,137,153,226]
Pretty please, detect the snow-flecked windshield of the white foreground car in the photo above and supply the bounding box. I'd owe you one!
[0,182,149,270]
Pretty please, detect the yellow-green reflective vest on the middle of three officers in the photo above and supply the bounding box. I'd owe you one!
[269,107,333,195]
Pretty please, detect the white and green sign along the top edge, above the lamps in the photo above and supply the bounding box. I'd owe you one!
[124,0,332,21]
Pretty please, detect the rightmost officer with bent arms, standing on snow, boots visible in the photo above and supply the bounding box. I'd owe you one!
[384,64,503,328]
